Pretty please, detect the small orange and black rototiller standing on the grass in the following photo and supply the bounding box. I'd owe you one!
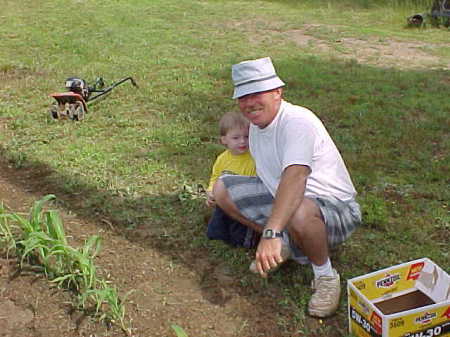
[50,77,137,121]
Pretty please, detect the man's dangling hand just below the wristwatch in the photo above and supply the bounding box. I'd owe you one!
[256,238,283,278]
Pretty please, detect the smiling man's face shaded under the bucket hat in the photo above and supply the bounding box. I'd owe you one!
[238,88,282,129]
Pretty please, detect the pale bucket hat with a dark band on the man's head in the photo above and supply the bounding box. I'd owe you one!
[231,57,285,99]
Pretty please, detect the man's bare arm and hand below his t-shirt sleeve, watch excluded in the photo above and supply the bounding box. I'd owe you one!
[256,165,311,277]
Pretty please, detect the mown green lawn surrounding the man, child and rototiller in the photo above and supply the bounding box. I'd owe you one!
[0,0,450,331]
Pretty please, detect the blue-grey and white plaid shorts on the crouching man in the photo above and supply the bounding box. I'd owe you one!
[220,174,361,263]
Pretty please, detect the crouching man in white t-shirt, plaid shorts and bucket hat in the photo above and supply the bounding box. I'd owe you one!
[214,57,361,317]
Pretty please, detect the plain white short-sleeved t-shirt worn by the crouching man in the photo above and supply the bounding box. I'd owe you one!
[249,101,356,201]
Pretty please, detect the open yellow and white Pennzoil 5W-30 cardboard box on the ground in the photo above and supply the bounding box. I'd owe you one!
[347,258,450,337]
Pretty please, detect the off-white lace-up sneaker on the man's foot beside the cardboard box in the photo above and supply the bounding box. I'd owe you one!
[308,269,341,317]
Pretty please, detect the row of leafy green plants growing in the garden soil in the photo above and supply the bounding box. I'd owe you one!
[0,195,129,332]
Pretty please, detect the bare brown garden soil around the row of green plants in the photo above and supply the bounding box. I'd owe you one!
[0,162,296,337]
